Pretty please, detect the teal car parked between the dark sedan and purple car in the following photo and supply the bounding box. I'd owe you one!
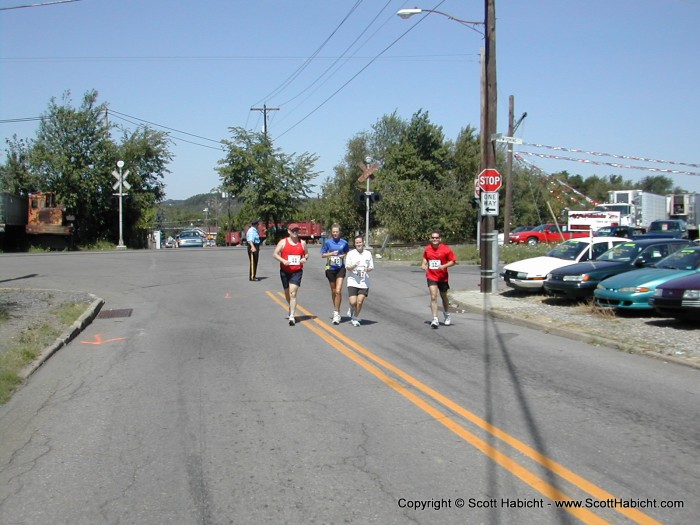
[593,246,700,310]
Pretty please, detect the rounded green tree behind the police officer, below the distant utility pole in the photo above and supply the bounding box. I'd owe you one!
[217,128,318,233]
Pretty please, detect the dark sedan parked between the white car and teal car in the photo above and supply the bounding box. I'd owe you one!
[544,238,692,299]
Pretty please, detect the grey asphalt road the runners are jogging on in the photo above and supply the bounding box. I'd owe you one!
[0,247,700,524]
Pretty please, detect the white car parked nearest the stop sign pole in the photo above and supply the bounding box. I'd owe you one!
[501,237,629,292]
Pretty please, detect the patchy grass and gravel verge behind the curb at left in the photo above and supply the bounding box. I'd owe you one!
[0,303,89,405]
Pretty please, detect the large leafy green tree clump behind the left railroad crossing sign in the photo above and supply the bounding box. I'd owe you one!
[0,90,172,246]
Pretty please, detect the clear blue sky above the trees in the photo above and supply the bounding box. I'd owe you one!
[0,0,700,199]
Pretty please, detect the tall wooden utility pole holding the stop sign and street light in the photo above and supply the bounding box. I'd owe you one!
[480,0,498,293]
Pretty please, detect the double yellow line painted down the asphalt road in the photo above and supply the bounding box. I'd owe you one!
[267,291,661,525]
